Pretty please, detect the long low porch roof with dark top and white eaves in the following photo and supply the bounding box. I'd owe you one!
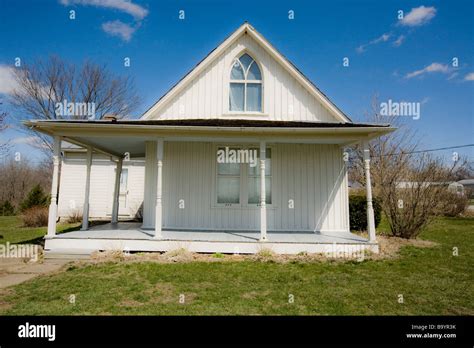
[24,119,395,157]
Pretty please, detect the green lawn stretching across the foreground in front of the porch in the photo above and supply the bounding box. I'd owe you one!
[0,218,474,315]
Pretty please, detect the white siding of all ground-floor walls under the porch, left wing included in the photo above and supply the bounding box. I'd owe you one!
[59,142,349,231]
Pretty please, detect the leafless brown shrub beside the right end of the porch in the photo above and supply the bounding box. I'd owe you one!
[349,97,465,238]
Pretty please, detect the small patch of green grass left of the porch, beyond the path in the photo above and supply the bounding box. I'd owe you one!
[0,216,79,244]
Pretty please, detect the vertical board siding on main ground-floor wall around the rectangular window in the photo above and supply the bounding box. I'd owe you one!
[159,142,348,231]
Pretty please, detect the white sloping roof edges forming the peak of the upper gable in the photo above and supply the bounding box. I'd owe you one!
[141,22,352,122]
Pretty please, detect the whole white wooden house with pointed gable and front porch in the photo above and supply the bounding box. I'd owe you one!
[27,23,393,253]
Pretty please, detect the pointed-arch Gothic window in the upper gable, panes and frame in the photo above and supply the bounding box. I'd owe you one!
[229,53,262,112]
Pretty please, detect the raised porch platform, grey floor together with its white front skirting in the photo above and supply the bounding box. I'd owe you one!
[45,222,378,254]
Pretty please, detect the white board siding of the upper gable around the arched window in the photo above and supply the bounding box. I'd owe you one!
[152,34,339,122]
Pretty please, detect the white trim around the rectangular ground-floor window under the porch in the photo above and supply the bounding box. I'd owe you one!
[211,143,277,210]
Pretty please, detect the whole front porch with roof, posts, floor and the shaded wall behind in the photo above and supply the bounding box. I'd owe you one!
[28,120,391,254]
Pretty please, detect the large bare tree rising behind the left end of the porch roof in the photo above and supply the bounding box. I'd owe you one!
[11,56,139,149]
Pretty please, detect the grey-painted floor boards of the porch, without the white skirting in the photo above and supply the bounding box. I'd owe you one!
[56,222,368,244]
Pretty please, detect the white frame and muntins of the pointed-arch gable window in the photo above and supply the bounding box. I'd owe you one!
[224,51,266,116]
